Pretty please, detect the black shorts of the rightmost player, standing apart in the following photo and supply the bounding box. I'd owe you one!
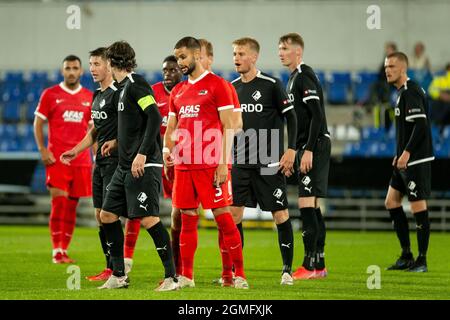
[389,161,431,201]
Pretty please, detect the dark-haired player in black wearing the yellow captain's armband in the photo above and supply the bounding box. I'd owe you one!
[100,41,178,291]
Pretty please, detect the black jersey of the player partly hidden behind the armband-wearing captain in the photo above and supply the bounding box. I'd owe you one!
[91,82,119,164]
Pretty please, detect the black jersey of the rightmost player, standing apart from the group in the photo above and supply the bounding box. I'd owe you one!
[395,79,434,166]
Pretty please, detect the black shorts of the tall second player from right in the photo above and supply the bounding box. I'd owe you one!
[295,136,331,198]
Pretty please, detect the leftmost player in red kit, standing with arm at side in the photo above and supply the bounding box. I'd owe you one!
[34,55,92,263]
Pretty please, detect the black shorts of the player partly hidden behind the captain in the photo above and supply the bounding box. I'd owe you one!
[92,159,118,209]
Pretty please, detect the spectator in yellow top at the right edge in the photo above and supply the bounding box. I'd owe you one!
[428,62,450,126]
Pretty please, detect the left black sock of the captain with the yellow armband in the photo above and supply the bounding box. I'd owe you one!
[103,220,125,277]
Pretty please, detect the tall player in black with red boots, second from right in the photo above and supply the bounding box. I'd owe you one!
[278,33,331,280]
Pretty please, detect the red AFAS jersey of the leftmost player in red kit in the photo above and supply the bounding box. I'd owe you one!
[34,82,92,166]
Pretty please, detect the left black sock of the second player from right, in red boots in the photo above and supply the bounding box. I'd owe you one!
[300,207,319,271]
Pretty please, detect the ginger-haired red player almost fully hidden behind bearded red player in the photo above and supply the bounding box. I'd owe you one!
[198,39,244,287]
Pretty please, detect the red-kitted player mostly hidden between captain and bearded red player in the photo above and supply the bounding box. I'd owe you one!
[152,55,183,274]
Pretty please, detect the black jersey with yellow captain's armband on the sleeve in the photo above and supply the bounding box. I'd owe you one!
[117,73,162,169]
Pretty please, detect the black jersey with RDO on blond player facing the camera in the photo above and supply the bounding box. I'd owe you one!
[232,71,295,167]
